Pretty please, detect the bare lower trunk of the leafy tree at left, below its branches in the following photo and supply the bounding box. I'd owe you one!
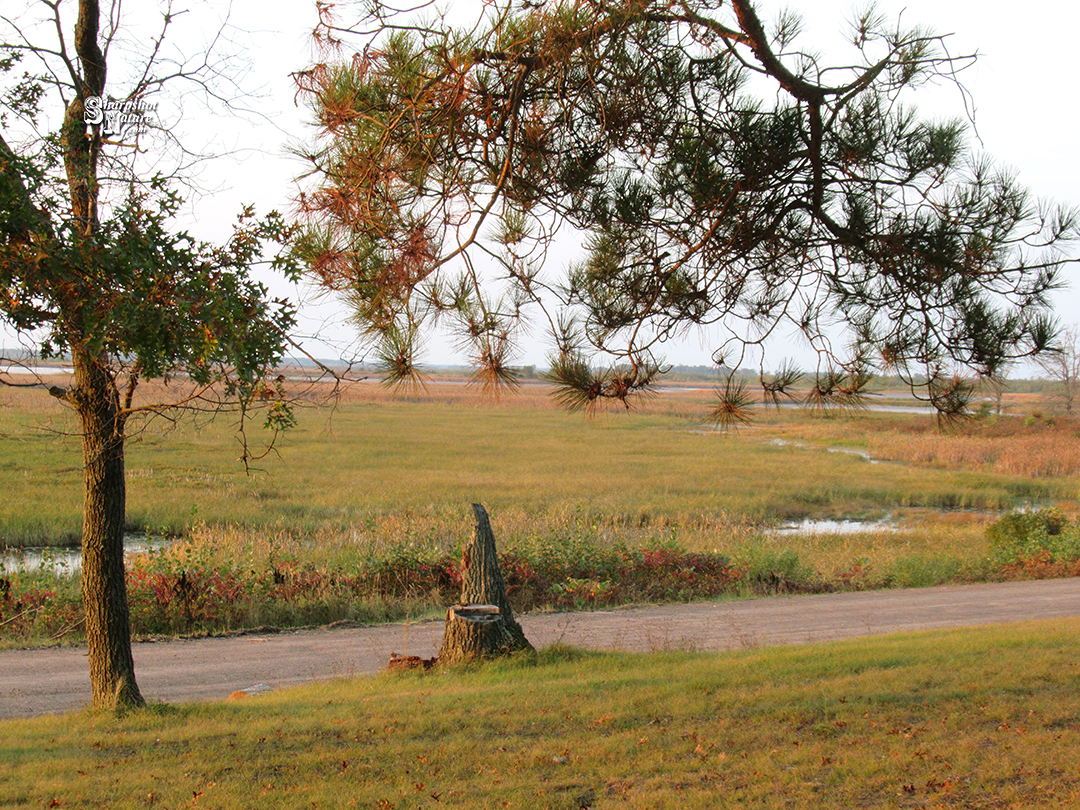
[72,347,144,708]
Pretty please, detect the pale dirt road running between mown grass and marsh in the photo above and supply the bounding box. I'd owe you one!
[0,579,1080,718]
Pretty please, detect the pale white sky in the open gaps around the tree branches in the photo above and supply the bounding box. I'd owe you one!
[4,0,1080,366]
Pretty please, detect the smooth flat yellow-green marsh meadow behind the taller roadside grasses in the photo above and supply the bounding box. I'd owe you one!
[0,394,1075,544]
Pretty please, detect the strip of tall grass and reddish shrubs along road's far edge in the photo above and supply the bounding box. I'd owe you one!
[0,508,1010,646]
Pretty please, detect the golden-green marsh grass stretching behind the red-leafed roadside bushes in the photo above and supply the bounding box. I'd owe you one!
[0,382,1077,604]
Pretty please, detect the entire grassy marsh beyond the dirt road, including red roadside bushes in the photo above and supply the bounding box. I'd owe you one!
[0,383,1080,646]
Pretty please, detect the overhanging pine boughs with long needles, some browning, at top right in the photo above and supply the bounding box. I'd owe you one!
[298,0,1077,420]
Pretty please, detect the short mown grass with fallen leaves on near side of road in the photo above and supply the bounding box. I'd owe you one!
[0,620,1080,810]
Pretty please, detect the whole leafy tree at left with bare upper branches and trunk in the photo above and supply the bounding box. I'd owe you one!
[0,0,293,707]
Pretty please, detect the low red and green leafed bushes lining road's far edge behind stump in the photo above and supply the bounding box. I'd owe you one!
[6,539,742,639]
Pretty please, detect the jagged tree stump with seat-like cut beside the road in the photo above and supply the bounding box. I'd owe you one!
[438,503,532,664]
